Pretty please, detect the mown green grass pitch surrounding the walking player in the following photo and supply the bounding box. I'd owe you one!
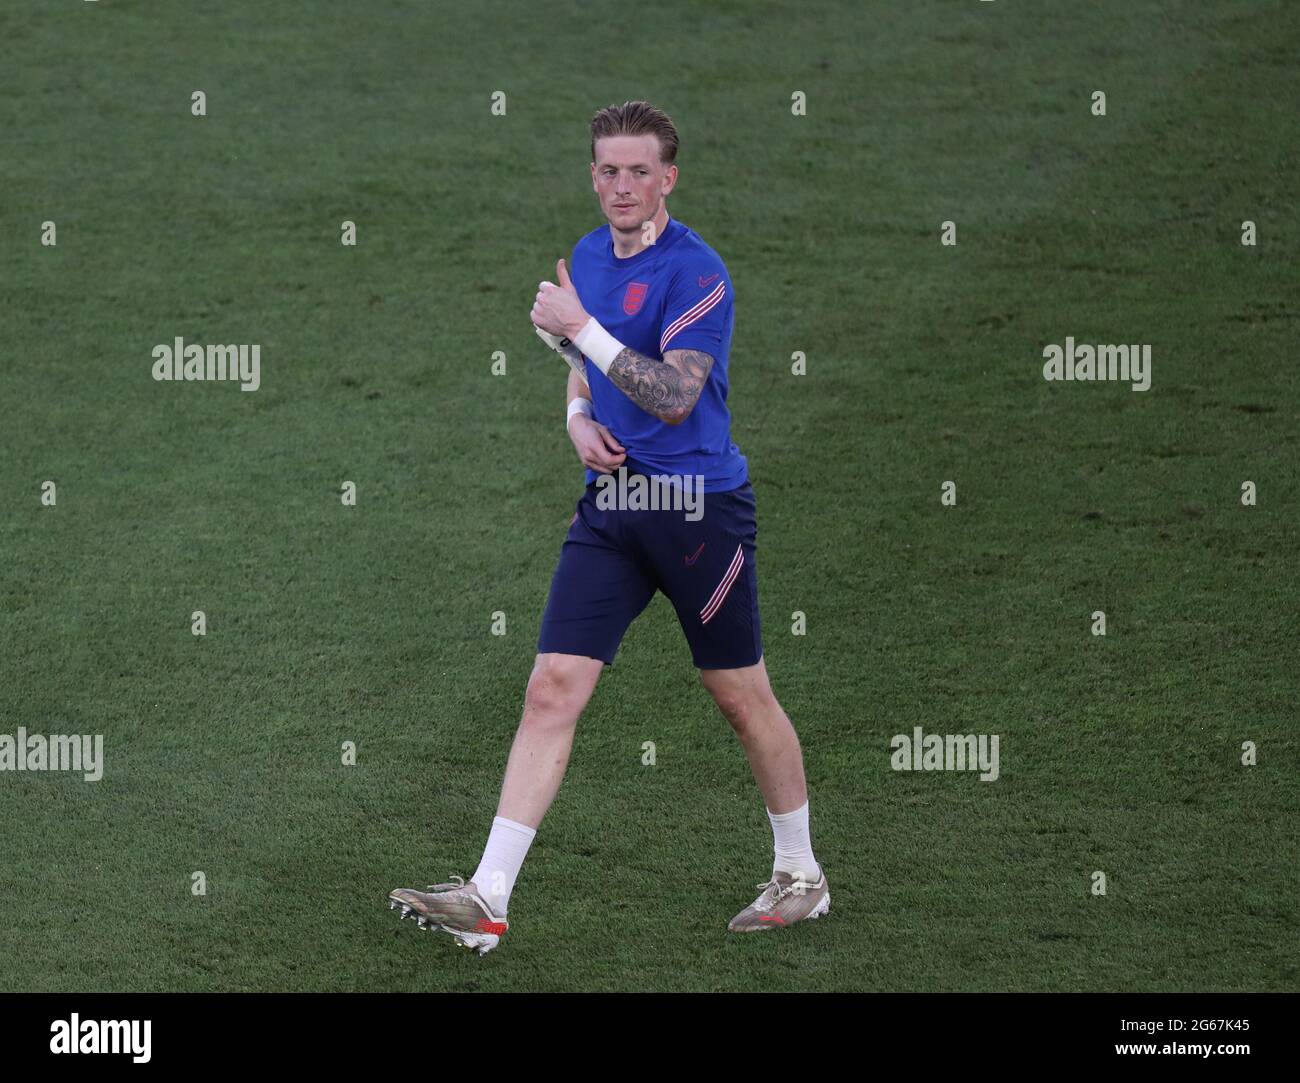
[0,0,1300,991]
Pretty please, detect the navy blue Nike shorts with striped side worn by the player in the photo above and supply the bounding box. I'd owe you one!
[537,468,763,670]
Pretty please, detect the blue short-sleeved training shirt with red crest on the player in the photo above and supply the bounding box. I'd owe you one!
[569,216,749,493]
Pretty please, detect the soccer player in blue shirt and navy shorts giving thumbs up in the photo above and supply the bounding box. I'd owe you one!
[389,101,831,953]
